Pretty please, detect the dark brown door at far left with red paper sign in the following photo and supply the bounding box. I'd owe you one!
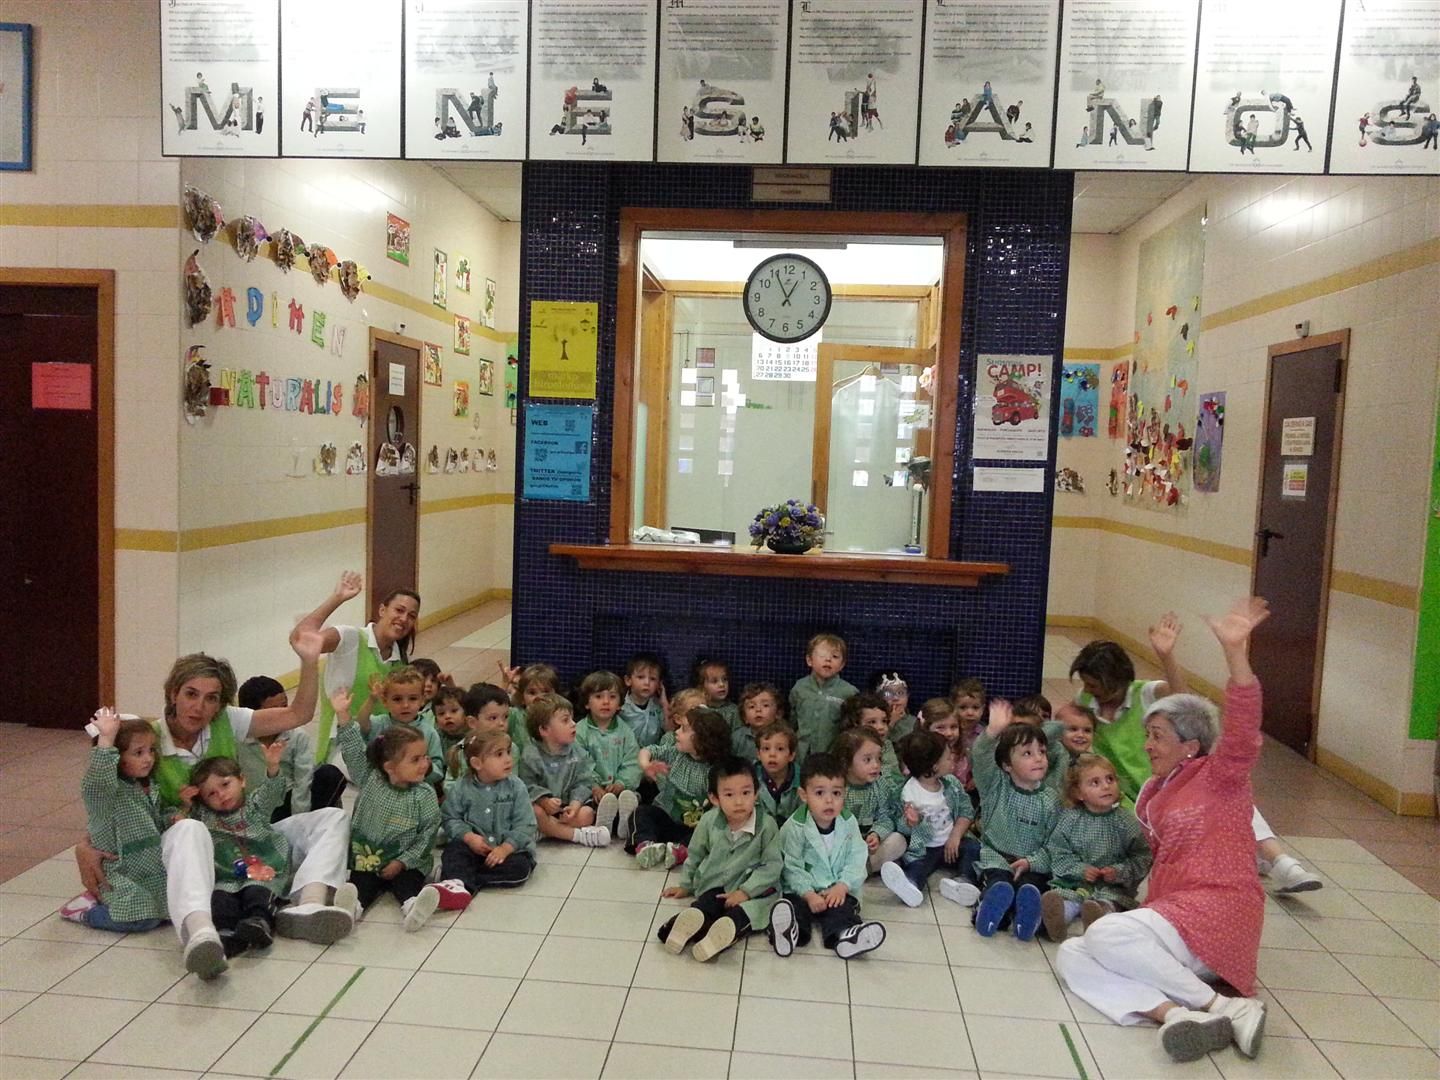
[0,275,114,727]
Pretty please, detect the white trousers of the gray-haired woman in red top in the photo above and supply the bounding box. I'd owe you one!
[1056,907,1215,1024]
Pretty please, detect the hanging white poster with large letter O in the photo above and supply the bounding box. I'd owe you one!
[1189,0,1354,173]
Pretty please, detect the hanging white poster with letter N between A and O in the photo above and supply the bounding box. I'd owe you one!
[1054,0,1200,171]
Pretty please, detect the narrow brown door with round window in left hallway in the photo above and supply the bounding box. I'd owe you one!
[366,330,420,608]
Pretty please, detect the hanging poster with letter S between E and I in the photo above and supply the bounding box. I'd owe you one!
[657,0,789,164]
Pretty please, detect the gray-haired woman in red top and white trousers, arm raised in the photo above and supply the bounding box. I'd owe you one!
[1057,598,1269,1061]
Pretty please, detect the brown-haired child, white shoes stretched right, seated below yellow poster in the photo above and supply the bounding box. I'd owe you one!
[517,694,611,848]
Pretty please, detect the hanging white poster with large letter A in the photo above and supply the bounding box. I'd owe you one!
[920,0,1060,168]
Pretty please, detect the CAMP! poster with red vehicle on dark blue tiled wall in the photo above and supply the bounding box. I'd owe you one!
[972,356,1053,461]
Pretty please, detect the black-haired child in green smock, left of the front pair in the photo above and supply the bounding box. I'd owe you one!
[660,756,783,960]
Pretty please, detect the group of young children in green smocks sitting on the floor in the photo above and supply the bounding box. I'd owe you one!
[70,625,1319,960]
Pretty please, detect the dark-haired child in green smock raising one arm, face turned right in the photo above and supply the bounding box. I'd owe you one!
[330,684,441,932]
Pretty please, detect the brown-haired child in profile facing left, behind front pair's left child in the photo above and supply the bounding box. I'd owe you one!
[635,711,730,870]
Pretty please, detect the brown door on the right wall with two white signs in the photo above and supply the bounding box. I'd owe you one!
[1251,330,1349,755]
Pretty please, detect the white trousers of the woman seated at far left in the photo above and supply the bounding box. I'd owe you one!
[160,806,350,942]
